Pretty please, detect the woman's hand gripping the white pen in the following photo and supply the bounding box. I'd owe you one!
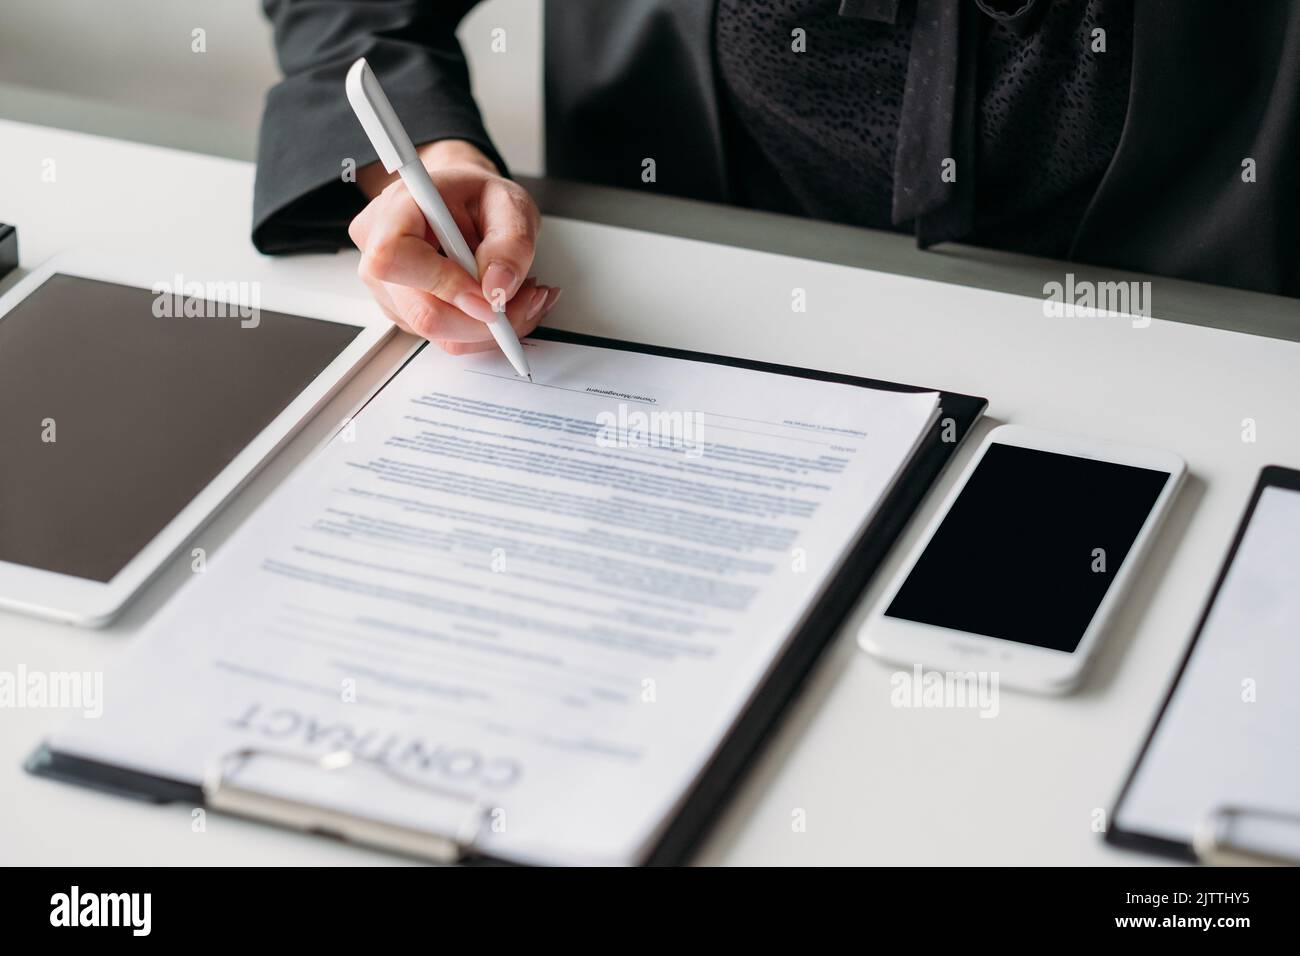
[347,139,560,354]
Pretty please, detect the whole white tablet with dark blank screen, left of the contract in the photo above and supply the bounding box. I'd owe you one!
[0,254,391,626]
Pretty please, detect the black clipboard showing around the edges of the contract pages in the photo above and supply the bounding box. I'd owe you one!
[25,328,988,866]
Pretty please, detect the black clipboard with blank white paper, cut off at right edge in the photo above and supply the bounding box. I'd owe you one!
[1106,467,1300,860]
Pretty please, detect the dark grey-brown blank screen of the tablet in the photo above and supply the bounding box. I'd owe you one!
[0,274,360,581]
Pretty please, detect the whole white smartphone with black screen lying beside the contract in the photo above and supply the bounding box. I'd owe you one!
[858,425,1187,693]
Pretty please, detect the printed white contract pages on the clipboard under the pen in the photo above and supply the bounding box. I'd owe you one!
[40,339,939,864]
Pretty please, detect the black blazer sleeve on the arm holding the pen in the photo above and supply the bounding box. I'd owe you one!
[252,0,506,254]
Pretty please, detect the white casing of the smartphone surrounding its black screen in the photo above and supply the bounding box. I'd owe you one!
[858,425,1187,693]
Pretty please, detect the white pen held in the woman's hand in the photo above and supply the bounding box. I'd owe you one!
[346,56,533,381]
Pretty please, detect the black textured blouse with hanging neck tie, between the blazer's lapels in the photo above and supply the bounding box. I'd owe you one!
[715,0,1134,258]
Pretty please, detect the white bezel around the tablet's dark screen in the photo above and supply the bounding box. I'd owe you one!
[0,252,394,627]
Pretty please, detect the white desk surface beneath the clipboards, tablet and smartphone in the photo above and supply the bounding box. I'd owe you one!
[0,122,1300,865]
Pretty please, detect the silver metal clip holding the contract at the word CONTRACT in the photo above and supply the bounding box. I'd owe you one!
[203,748,489,864]
